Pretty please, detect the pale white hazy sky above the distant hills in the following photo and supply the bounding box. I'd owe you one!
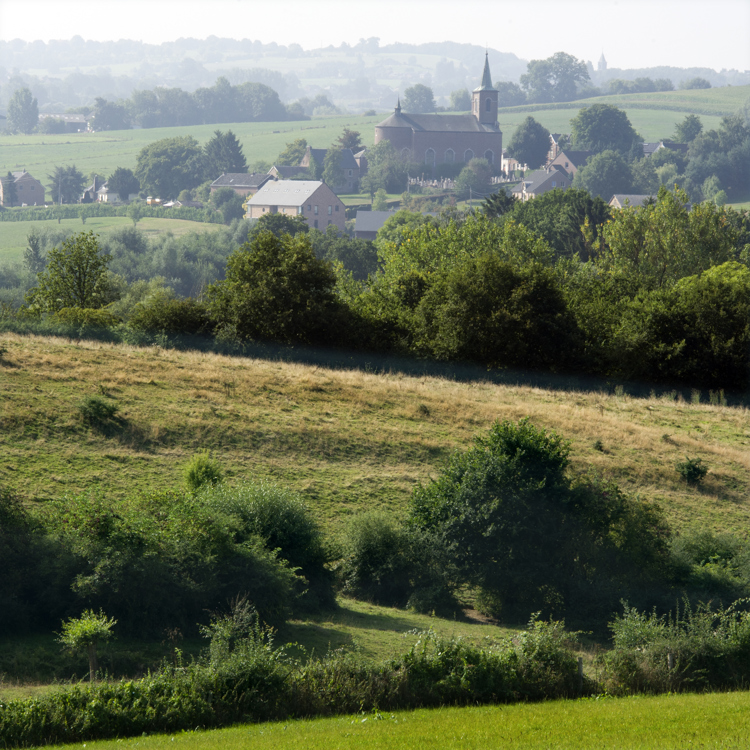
[0,0,750,70]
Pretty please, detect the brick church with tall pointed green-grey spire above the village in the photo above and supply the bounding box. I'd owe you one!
[375,55,503,171]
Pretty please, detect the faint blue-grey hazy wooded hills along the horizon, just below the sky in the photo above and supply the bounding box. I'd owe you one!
[0,36,750,114]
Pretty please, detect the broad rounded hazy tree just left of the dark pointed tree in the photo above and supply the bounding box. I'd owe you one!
[135,135,205,200]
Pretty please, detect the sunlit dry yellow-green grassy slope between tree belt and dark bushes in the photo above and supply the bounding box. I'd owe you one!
[0,334,750,533]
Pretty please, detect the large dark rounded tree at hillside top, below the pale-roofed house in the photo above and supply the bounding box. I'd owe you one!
[207,232,338,344]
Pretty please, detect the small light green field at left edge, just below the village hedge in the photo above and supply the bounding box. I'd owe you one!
[0,216,222,262]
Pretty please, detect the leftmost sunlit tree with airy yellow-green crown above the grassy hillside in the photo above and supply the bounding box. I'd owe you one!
[26,232,112,312]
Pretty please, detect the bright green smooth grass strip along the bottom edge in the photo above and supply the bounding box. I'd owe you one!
[30,692,750,750]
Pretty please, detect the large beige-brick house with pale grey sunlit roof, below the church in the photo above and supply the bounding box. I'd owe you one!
[245,180,346,232]
